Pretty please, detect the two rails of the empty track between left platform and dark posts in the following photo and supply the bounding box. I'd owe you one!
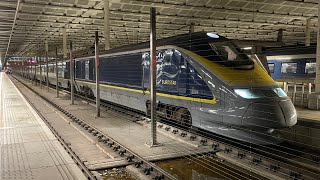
[14,77,176,180]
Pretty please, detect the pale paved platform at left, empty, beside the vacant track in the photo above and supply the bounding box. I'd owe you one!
[0,72,86,180]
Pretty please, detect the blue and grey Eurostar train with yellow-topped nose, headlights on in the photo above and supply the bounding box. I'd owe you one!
[20,32,297,144]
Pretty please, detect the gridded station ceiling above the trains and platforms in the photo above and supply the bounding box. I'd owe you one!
[0,0,318,59]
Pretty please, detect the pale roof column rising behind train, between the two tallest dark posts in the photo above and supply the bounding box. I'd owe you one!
[103,0,110,50]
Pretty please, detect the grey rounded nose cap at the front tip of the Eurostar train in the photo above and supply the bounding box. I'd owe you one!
[278,100,297,127]
